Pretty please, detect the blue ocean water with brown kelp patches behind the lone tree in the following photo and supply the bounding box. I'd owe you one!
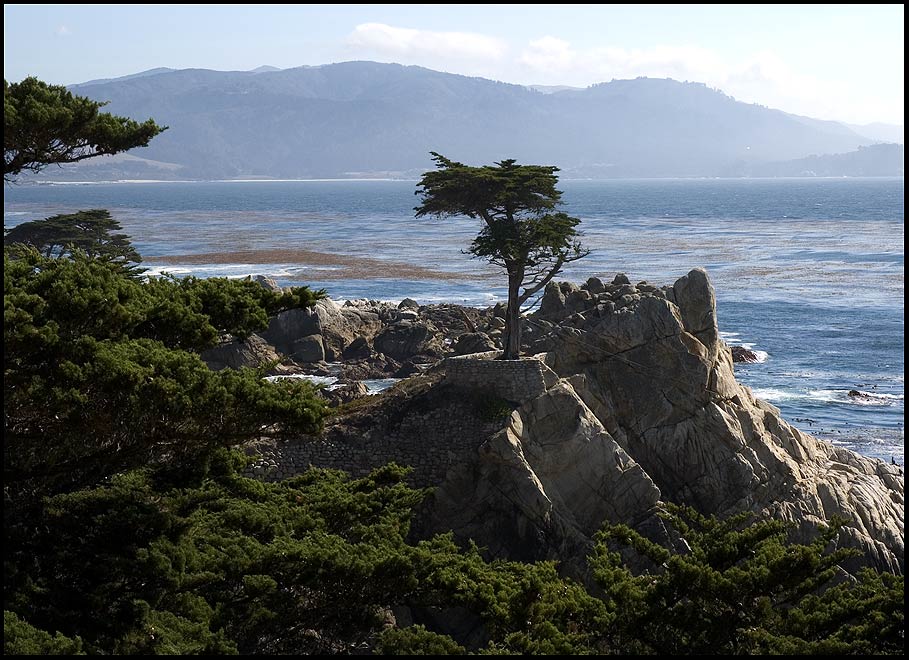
[4,178,904,464]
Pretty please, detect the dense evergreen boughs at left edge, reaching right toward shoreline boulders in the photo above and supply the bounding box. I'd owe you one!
[3,250,324,497]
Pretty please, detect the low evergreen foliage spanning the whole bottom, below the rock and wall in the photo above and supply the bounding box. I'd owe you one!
[4,449,903,655]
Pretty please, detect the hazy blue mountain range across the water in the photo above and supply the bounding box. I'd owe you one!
[28,62,902,179]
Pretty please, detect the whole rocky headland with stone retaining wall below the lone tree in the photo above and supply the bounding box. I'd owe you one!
[243,269,904,576]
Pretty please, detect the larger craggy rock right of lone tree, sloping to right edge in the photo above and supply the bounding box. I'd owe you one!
[547,269,904,570]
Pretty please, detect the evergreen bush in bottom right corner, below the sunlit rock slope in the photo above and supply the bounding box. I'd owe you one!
[591,505,904,655]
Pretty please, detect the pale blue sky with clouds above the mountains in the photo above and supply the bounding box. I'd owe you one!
[3,4,905,124]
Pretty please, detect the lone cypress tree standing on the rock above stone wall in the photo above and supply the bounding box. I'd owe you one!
[414,152,588,360]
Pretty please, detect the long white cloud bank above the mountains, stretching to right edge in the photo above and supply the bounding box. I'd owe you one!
[346,23,903,123]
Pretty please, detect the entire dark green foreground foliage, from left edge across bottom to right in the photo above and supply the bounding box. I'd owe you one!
[4,250,903,654]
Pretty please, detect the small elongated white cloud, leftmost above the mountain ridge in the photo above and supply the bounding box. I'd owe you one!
[347,23,507,63]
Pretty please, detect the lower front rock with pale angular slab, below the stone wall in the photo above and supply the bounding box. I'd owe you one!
[428,380,672,576]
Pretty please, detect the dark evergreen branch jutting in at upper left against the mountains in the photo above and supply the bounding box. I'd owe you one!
[3,77,167,181]
